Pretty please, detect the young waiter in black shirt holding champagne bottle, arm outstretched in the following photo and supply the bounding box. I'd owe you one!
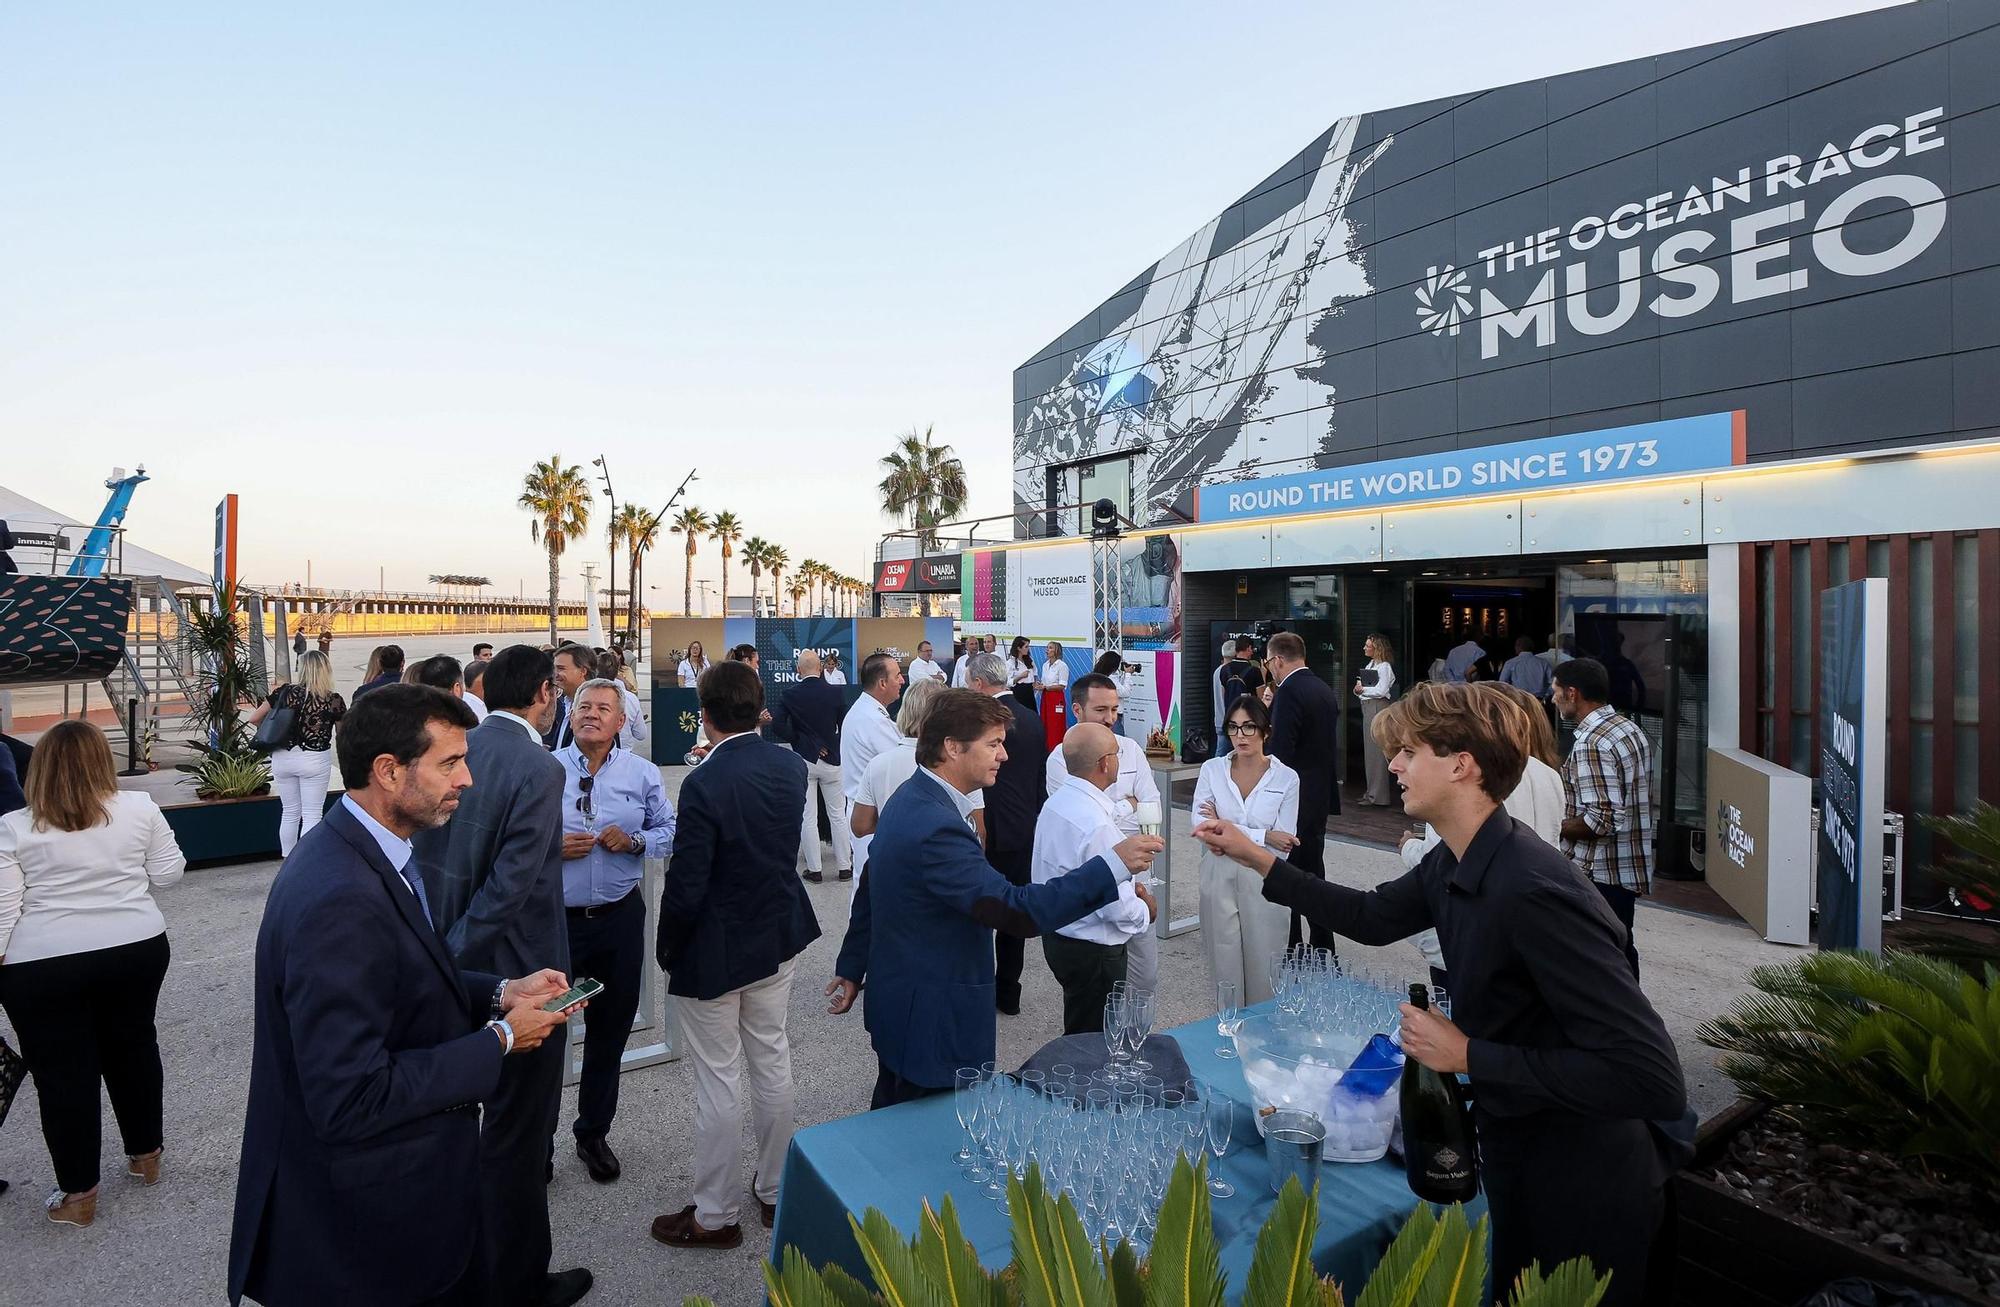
[1194,681,1686,1305]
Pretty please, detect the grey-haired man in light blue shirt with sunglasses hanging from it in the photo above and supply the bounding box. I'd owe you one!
[554,679,674,1185]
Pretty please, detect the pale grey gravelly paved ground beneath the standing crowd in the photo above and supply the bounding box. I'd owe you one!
[0,771,1792,1307]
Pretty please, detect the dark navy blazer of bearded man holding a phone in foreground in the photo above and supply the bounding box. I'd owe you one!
[230,805,502,1307]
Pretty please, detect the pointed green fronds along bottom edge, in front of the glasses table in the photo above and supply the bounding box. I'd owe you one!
[686,1157,1610,1307]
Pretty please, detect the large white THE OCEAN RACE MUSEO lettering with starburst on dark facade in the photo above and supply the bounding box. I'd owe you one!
[1416,106,1946,358]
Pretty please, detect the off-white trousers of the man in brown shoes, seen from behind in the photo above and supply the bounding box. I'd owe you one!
[674,959,796,1229]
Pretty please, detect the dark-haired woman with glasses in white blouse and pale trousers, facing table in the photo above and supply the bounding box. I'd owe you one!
[1194,693,1298,1005]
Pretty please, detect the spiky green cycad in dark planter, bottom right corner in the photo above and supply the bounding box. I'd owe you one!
[1676,953,2000,1305]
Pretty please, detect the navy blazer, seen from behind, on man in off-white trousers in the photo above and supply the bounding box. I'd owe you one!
[654,735,820,999]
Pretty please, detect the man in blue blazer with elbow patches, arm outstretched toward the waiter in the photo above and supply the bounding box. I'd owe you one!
[826,689,1164,1107]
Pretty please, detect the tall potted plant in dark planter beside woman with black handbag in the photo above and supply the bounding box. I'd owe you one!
[162,584,280,861]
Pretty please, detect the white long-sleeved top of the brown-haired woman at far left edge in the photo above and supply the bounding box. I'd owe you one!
[0,789,188,965]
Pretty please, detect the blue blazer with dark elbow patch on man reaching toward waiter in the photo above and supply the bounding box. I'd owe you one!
[834,771,1118,1089]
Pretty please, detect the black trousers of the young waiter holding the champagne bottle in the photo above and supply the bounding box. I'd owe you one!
[1480,1113,1666,1307]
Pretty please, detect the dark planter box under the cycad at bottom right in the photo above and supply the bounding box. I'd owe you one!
[1674,1101,2000,1307]
